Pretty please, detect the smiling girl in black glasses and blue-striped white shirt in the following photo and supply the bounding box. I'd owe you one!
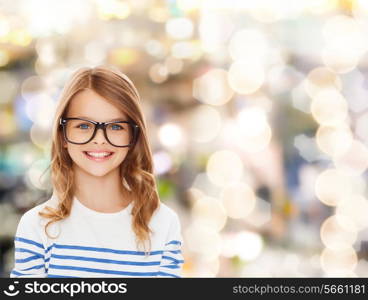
[10,66,184,277]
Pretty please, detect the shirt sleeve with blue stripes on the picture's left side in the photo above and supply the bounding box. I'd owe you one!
[10,210,47,277]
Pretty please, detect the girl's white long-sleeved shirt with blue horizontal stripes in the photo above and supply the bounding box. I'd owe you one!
[10,194,184,277]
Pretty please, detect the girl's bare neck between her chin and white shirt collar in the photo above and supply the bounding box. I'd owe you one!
[74,166,130,213]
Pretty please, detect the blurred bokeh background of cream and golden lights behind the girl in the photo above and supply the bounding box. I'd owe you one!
[0,0,368,277]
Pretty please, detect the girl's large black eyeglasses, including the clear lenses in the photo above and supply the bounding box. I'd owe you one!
[59,118,139,147]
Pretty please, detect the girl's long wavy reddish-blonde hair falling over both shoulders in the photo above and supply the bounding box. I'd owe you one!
[39,66,160,255]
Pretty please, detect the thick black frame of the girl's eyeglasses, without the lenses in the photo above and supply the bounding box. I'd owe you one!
[59,117,139,148]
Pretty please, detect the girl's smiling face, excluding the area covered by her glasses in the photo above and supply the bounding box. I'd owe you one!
[64,89,130,177]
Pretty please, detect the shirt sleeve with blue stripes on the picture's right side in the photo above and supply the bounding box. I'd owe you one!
[157,214,184,278]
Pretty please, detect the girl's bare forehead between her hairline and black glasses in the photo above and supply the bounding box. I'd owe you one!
[67,89,127,122]
